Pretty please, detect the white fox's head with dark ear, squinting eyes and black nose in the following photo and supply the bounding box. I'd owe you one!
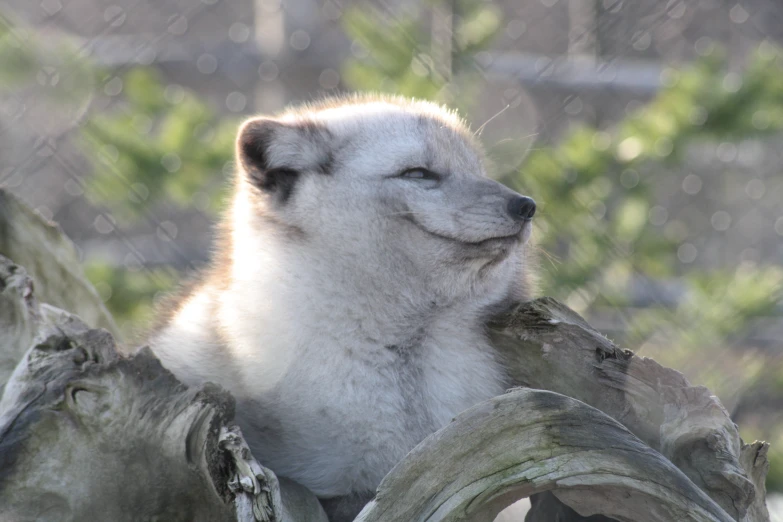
[234,97,535,304]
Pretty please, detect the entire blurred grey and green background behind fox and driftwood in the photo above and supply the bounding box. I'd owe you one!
[0,0,783,500]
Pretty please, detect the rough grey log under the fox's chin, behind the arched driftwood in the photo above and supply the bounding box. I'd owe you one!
[489,298,769,522]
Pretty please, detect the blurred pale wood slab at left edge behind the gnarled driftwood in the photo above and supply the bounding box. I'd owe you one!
[0,188,119,338]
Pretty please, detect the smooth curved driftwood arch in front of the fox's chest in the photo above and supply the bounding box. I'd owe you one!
[356,389,733,522]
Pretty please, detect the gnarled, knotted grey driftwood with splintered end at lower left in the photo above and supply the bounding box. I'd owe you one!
[0,256,326,522]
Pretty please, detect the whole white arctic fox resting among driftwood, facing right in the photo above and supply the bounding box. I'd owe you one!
[151,96,536,520]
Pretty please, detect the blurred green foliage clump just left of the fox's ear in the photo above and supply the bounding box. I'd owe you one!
[82,68,239,220]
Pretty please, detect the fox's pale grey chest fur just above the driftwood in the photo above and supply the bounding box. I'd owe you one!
[239,336,505,496]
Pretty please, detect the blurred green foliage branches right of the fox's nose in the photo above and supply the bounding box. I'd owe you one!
[506,49,783,336]
